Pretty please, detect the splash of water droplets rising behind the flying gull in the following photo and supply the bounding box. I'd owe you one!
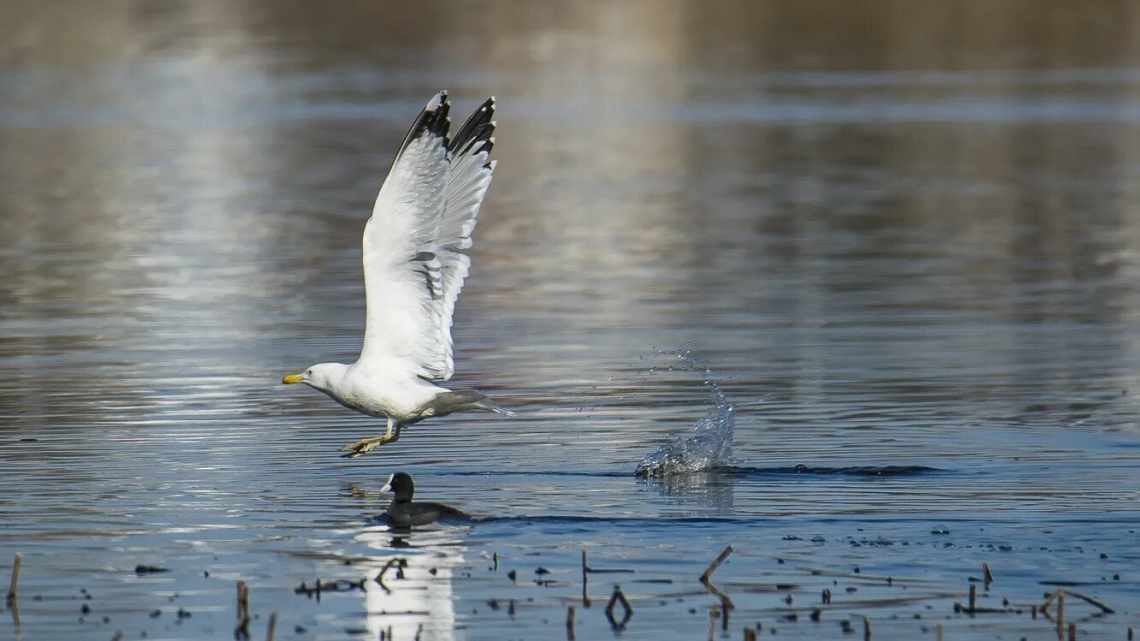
[634,350,736,478]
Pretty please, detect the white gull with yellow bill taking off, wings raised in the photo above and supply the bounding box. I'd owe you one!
[282,91,513,457]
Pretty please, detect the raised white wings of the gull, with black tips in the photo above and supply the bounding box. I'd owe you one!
[360,91,495,381]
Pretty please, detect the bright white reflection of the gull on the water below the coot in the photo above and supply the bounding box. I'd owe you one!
[356,526,466,641]
